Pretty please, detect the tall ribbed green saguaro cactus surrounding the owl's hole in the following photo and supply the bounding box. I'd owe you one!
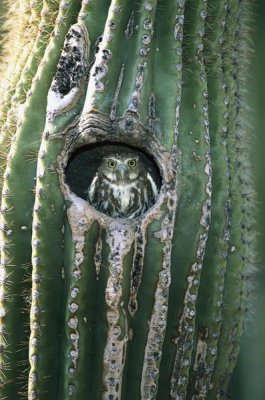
[0,0,253,400]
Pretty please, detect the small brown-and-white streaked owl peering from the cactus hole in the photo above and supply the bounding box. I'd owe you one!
[88,149,158,218]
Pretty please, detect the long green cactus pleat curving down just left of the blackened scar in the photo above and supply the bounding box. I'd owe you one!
[1,2,83,398]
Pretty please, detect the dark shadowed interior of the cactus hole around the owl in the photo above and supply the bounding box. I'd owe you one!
[65,143,162,200]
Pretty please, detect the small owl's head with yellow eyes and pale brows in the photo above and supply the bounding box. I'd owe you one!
[98,152,144,184]
